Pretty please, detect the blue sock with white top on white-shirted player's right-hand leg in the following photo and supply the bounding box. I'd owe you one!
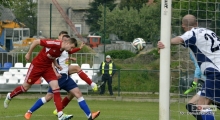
[77,97,91,118]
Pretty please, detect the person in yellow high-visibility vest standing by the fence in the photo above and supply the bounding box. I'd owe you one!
[100,55,116,95]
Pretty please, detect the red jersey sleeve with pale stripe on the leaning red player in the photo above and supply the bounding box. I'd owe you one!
[40,39,61,48]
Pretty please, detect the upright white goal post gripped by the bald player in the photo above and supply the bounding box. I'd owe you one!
[159,0,172,120]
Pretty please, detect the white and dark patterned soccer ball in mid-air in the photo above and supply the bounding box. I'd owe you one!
[131,38,146,51]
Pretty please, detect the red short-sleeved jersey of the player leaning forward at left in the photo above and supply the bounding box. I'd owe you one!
[32,39,63,67]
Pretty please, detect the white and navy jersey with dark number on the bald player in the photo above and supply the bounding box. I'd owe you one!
[179,27,220,73]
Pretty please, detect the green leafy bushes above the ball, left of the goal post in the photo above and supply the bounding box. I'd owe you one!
[98,3,160,43]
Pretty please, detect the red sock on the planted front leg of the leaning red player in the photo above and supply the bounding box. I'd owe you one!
[53,89,63,112]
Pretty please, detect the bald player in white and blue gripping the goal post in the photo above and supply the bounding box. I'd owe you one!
[157,14,220,120]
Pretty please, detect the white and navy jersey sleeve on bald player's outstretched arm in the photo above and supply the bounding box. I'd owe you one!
[179,31,196,47]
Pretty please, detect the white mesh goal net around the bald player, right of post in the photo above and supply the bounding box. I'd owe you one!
[160,0,220,120]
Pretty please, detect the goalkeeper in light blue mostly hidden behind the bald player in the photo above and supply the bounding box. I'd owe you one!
[184,50,206,94]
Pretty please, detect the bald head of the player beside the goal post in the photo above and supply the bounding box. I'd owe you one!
[182,14,197,29]
